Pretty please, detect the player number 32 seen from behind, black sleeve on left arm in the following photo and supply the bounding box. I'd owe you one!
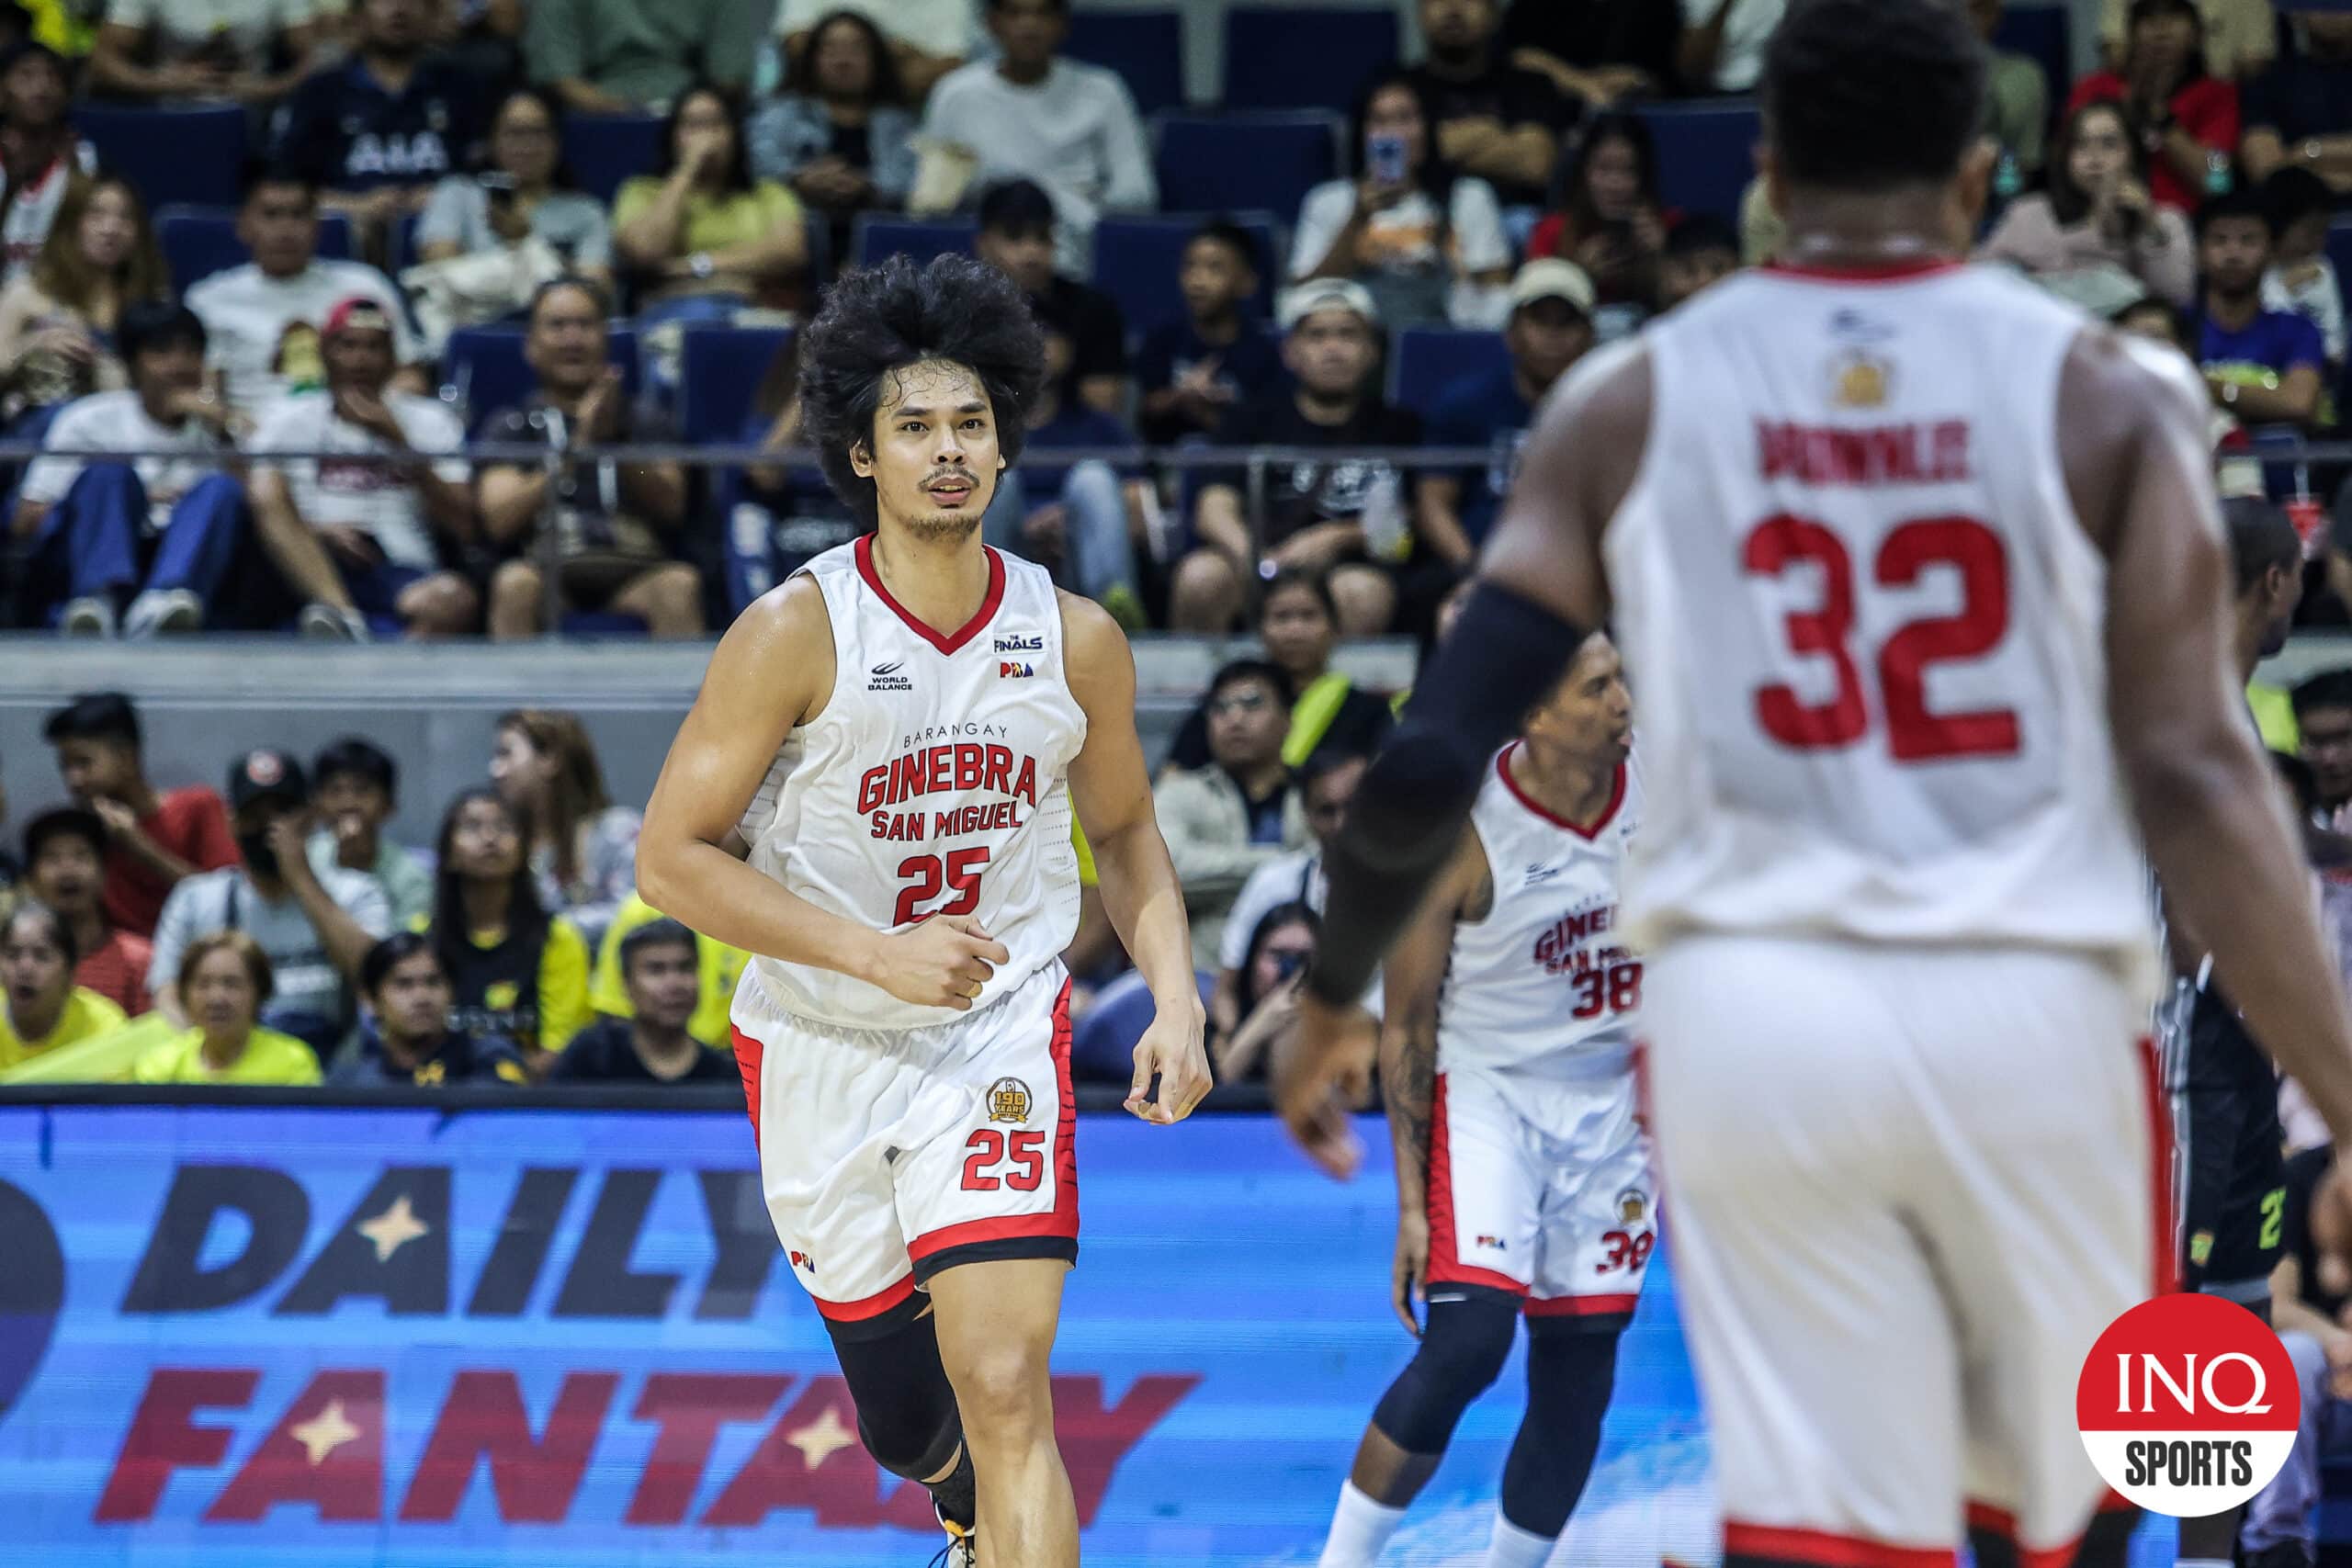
[1282,0,2352,1568]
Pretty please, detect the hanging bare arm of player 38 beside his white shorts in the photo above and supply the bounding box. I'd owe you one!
[1381,828,1491,1336]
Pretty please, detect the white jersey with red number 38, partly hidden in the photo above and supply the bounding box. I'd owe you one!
[1437,743,1642,1075]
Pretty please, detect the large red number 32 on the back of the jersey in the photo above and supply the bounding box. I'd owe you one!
[1740,513,2018,761]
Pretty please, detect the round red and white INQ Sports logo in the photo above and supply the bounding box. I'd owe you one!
[2075,1295,2302,1518]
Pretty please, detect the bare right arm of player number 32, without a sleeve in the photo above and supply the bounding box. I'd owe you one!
[2088,333,2352,1149]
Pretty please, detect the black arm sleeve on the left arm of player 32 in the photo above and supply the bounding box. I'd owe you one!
[1307,583,1588,1006]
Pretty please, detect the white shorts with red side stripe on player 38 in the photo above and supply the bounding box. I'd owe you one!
[1425,1067,1658,1328]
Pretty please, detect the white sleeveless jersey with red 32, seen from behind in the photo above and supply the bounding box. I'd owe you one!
[1604,265,2154,985]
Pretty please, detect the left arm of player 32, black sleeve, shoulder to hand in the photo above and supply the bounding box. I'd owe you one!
[1275,348,1651,1178]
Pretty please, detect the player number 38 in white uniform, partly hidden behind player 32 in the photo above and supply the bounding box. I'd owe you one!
[1322,635,1656,1568]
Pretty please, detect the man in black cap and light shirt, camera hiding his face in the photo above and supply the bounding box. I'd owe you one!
[148,748,393,1058]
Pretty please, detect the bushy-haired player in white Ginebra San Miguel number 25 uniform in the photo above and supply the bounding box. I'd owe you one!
[638,256,1209,1568]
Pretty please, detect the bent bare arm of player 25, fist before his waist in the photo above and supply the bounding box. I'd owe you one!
[638,579,1007,1010]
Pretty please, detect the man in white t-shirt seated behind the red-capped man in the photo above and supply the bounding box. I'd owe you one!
[188,169,424,416]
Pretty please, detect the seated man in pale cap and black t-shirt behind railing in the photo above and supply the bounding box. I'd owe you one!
[1169,277,1452,637]
